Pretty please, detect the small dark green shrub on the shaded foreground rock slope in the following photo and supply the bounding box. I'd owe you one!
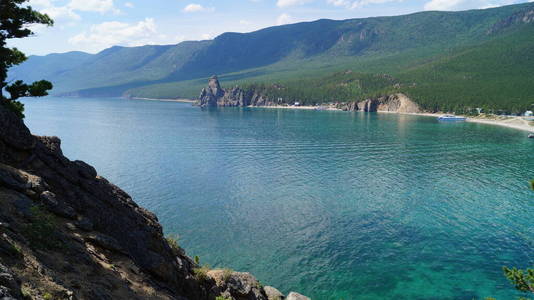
[24,205,61,250]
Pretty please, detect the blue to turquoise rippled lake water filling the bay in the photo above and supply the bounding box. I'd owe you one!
[25,97,534,300]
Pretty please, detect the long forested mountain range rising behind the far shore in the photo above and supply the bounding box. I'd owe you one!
[10,3,534,111]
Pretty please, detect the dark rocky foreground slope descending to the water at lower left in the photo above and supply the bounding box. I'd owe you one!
[0,101,307,300]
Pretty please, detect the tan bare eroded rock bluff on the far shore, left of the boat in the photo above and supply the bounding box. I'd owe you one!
[338,93,421,113]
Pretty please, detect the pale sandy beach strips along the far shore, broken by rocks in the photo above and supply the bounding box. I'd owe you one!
[128,97,534,133]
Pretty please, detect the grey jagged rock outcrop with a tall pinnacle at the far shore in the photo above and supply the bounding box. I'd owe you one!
[199,76,273,107]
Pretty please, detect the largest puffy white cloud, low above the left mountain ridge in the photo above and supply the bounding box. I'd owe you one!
[69,18,185,51]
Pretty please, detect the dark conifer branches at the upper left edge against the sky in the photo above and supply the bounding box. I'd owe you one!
[0,0,54,117]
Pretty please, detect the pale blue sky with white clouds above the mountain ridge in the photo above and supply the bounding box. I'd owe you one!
[9,0,534,55]
